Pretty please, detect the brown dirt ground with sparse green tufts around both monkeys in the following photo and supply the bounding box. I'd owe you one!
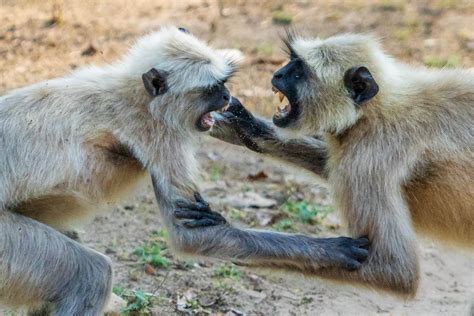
[0,0,474,315]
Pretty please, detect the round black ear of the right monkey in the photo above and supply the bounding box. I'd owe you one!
[344,66,379,105]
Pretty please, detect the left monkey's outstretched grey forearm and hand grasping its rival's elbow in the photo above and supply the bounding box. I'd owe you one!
[152,175,369,272]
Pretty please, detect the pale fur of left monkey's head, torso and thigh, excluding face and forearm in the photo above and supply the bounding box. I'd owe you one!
[0,27,241,316]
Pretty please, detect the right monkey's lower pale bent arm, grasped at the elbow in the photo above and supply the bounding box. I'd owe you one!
[320,166,419,297]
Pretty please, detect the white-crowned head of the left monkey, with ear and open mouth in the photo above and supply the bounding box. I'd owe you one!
[125,27,240,135]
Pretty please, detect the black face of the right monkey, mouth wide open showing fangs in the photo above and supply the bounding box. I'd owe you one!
[272,57,308,127]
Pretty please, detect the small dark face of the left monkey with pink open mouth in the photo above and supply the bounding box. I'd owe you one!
[196,83,230,132]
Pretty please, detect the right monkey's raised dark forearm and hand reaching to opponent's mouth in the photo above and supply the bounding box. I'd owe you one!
[210,98,328,179]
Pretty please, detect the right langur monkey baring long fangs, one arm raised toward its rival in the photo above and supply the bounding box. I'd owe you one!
[211,35,474,297]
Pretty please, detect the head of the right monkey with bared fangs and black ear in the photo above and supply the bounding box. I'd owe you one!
[272,33,387,135]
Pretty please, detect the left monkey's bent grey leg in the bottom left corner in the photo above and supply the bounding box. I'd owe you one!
[0,211,112,316]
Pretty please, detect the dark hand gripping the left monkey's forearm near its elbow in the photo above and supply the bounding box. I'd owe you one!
[174,192,227,228]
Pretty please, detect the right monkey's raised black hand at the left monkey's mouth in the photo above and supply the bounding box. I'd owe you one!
[210,97,275,153]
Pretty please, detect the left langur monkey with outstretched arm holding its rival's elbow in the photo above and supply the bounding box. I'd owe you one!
[0,27,368,316]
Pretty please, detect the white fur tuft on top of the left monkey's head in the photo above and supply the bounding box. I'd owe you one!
[121,26,242,93]
